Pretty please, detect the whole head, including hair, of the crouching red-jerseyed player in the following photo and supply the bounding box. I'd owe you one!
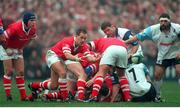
[75,27,88,45]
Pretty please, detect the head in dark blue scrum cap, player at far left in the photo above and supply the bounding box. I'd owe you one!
[23,12,37,28]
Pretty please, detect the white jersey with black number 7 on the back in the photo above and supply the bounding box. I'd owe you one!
[125,63,151,97]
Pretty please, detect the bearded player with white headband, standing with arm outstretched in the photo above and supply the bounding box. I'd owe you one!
[126,13,180,102]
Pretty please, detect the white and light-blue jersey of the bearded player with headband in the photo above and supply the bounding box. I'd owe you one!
[136,23,180,61]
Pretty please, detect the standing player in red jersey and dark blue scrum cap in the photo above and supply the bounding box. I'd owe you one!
[0,12,37,101]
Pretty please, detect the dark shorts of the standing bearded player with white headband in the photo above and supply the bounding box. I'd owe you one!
[156,58,180,68]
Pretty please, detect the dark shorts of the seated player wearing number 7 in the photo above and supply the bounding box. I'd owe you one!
[132,82,156,102]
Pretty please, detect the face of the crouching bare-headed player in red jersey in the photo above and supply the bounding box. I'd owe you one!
[76,33,87,45]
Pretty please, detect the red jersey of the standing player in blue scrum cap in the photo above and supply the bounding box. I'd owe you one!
[4,21,37,49]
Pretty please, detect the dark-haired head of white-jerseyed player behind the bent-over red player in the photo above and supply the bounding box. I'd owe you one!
[101,21,116,37]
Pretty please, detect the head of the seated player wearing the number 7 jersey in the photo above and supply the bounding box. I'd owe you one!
[131,54,144,64]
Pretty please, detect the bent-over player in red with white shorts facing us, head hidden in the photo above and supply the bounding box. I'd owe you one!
[86,38,131,102]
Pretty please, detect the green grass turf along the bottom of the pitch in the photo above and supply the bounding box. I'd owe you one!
[0,80,180,107]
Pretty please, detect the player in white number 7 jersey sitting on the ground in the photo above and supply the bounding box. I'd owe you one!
[125,54,156,102]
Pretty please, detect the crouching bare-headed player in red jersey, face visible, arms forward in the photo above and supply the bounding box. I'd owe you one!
[30,27,96,101]
